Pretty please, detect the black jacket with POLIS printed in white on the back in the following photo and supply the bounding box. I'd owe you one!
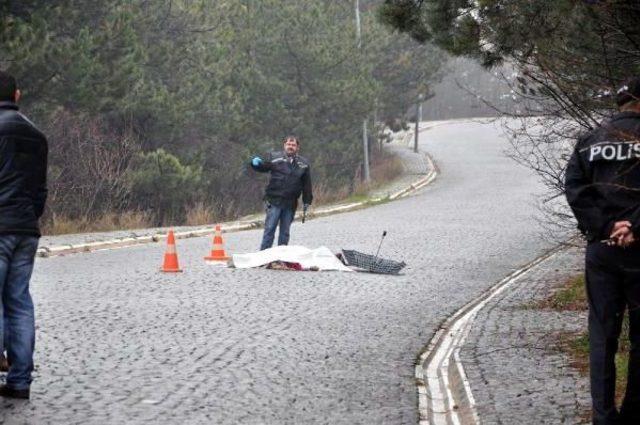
[565,112,640,241]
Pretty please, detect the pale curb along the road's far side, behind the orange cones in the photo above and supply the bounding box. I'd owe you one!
[36,133,438,258]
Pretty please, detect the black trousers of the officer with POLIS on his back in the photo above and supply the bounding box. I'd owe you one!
[586,242,640,425]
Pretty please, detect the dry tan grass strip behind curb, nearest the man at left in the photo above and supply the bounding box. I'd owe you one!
[42,211,152,235]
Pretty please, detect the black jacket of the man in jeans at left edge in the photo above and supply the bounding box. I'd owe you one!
[0,102,48,236]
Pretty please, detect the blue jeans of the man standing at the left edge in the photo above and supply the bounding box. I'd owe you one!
[0,235,38,390]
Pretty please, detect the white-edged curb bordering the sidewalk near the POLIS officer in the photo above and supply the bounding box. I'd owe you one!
[415,244,568,425]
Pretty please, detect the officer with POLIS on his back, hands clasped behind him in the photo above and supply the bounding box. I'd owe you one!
[565,78,640,424]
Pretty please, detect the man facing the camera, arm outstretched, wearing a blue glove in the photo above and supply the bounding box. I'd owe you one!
[251,136,313,250]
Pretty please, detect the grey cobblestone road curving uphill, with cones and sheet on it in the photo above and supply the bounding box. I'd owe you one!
[0,118,550,425]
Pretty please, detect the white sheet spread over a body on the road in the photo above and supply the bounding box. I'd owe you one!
[233,245,353,272]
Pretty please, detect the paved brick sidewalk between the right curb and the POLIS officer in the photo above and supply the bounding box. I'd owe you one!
[460,249,590,425]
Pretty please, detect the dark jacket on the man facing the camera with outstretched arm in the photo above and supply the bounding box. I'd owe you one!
[251,152,313,209]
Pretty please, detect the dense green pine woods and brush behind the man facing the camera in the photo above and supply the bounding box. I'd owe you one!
[0,0,447,233]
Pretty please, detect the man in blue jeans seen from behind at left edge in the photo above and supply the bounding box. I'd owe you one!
[0,71,47,398]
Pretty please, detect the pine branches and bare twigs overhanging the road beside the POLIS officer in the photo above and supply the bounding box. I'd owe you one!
[380,0,640,232]
